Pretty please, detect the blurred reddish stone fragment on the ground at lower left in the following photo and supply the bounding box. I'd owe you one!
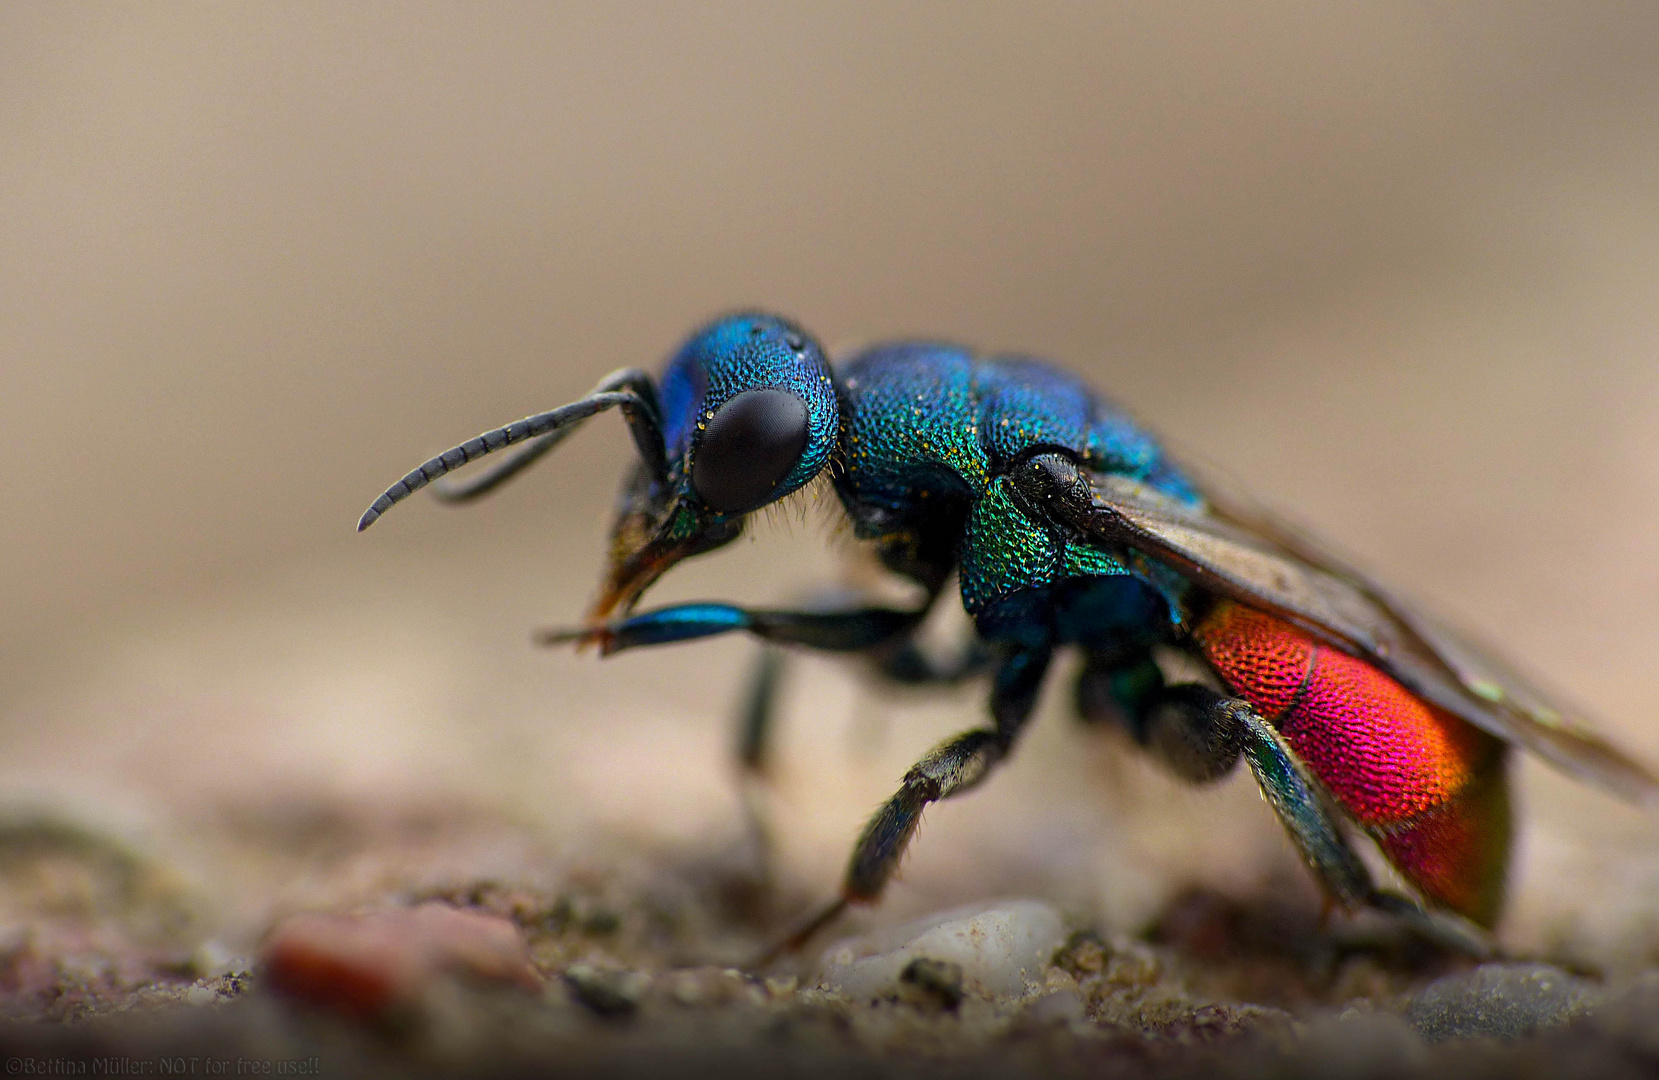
[264,902,541,1019]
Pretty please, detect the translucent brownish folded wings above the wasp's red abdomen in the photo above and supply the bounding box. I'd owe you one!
[1073,474,1659,805]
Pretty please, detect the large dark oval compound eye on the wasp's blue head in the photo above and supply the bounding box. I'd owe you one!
[692,390,806,514]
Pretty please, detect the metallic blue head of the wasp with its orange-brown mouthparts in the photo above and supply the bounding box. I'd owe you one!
[589,312,841,620]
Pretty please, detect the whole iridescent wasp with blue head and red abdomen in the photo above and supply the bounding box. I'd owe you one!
[357,312,1659,951]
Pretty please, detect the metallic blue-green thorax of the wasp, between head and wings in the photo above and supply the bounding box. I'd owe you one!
[836,342,1198,642]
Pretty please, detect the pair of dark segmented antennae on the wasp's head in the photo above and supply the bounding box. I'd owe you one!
[357,368,667,533]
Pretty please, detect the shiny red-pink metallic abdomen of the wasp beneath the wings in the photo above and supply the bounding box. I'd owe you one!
[1193,601,1510,926]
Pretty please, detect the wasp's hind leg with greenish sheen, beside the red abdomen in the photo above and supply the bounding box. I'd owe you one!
[1145,684,1491,956]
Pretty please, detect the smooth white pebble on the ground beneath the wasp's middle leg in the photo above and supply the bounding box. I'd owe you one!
[821,899,1065,1000]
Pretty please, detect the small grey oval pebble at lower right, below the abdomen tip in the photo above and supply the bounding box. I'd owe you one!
[1405,964,1598,1042]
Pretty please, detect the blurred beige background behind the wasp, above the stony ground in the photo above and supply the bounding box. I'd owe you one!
[0,3,1659,962]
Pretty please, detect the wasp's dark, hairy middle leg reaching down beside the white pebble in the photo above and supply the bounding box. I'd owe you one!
[758,645,1053,966]
